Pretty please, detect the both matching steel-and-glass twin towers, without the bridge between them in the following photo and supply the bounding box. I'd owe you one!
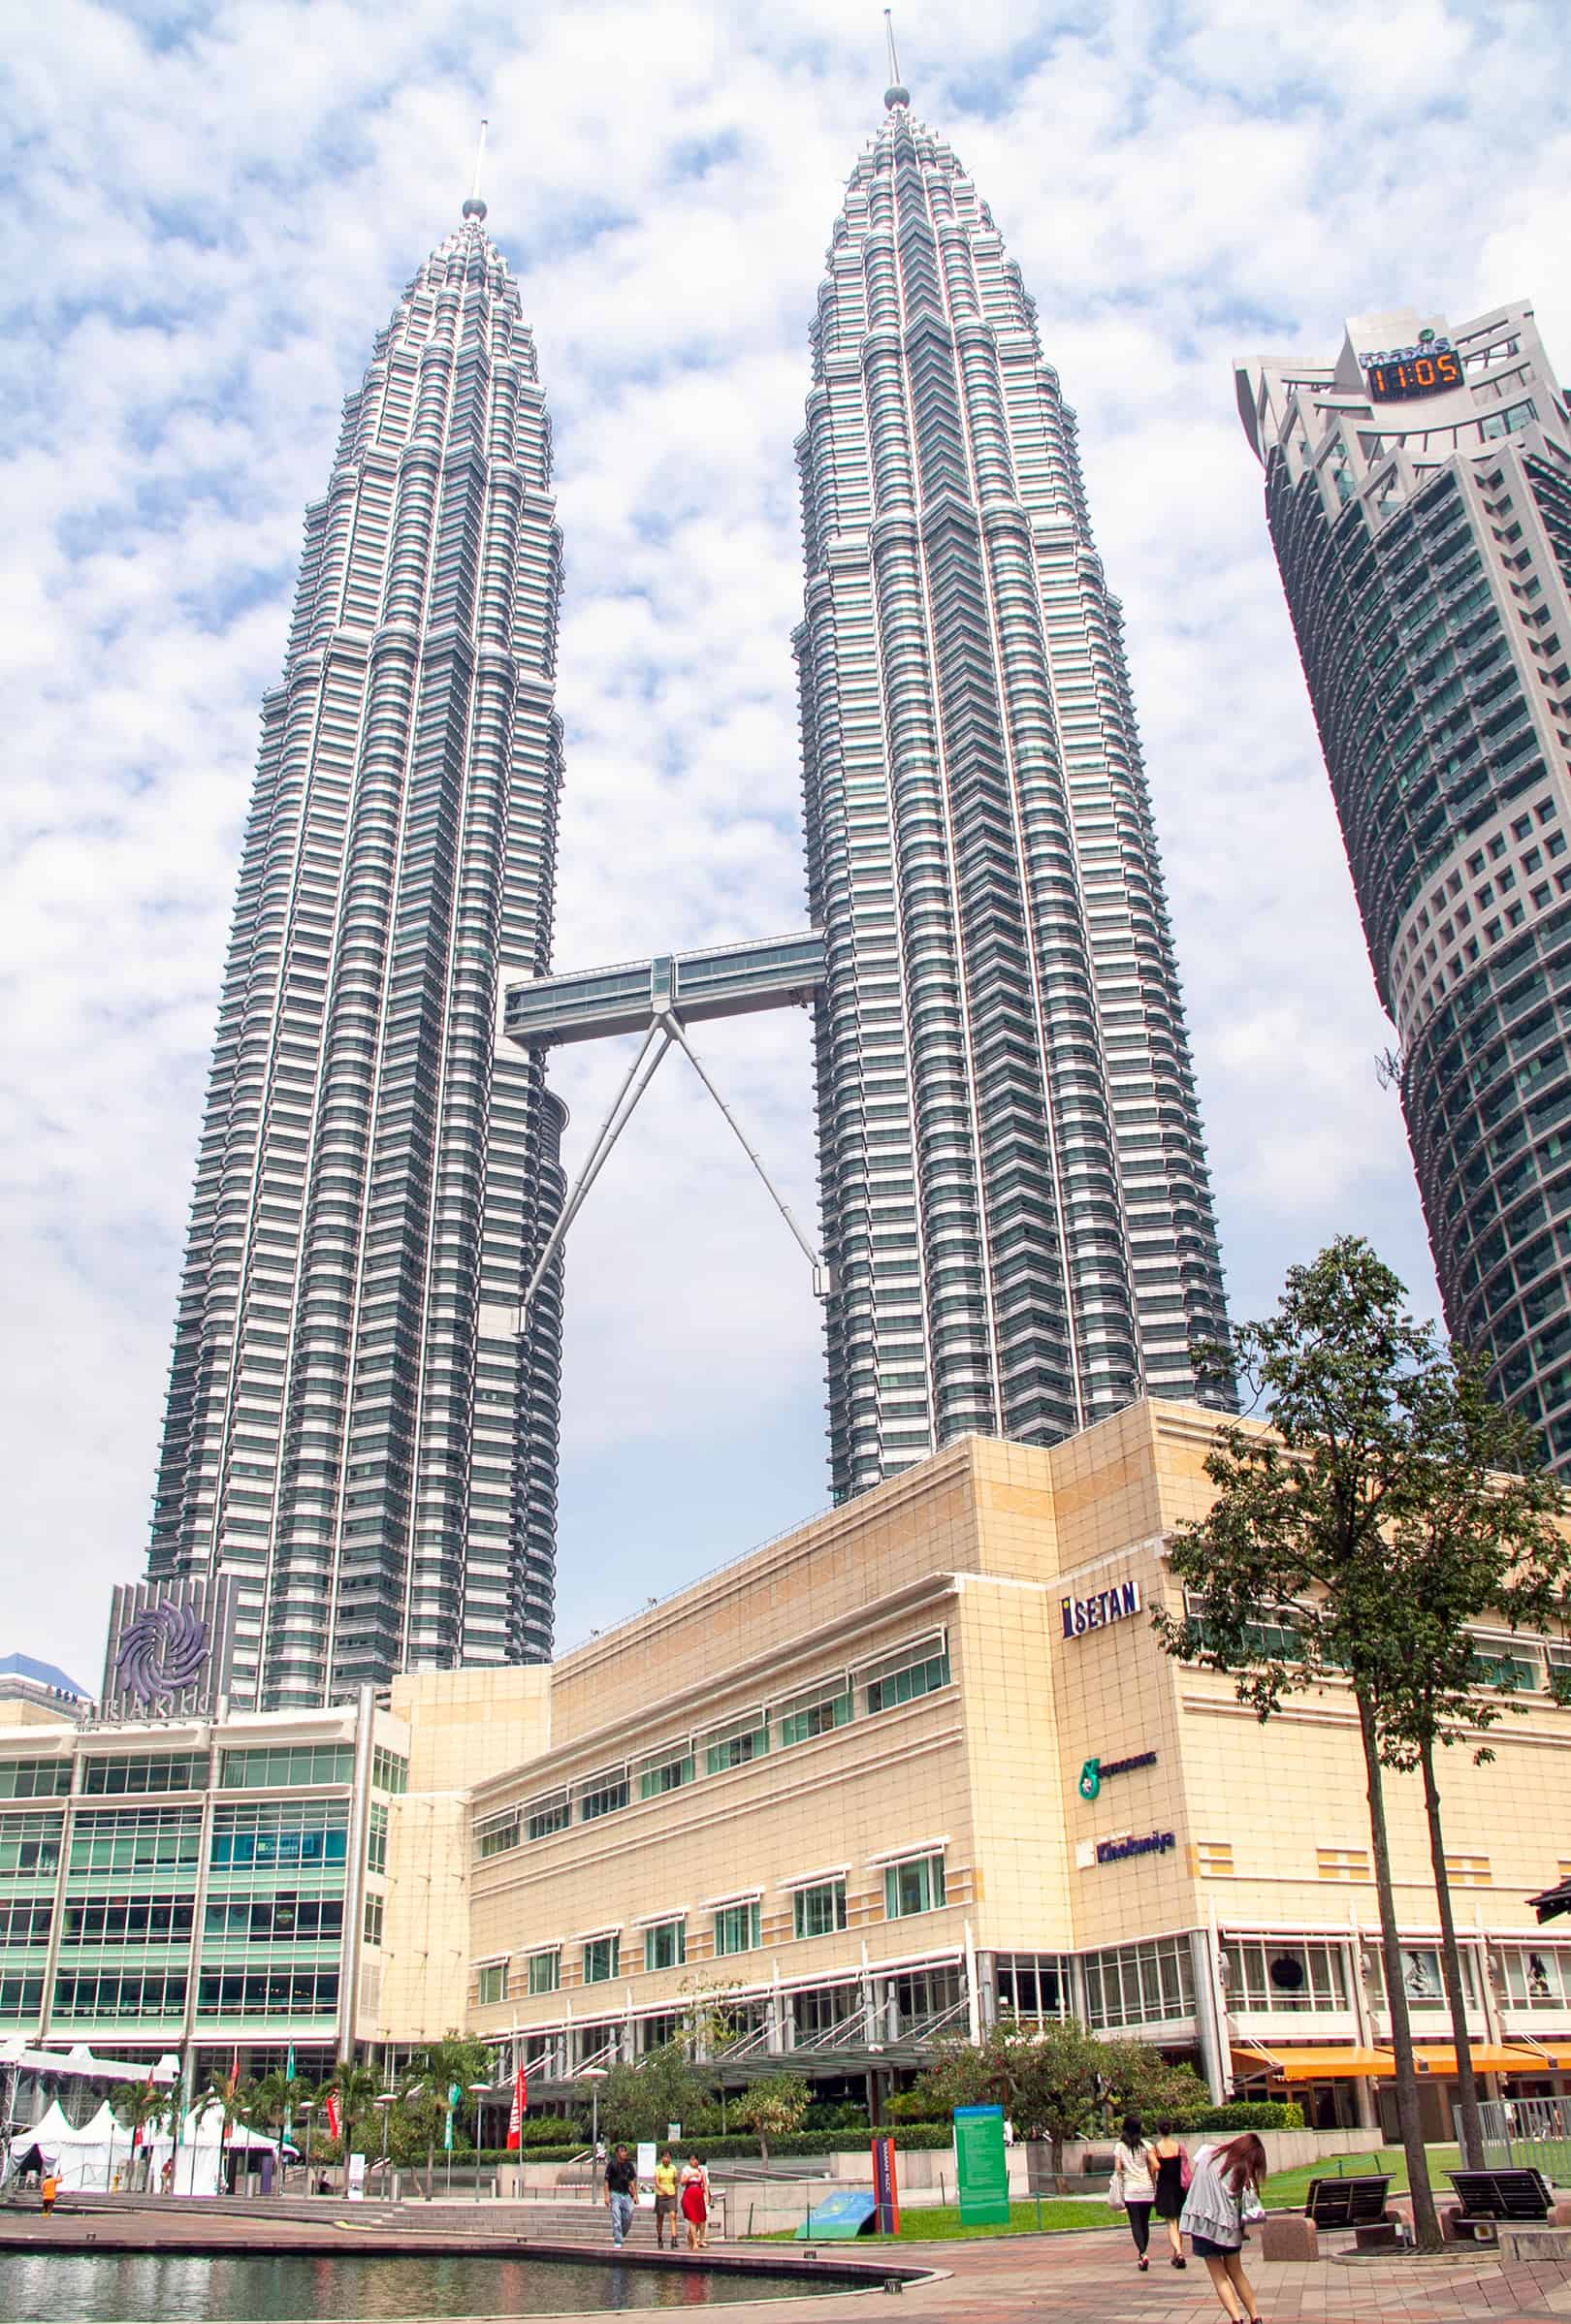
[148,86,1225,1708]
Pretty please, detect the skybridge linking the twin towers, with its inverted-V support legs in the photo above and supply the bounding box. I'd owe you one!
[502,930,832,1329]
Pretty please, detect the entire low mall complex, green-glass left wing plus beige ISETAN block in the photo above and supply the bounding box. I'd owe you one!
[0,1401,1571,2133]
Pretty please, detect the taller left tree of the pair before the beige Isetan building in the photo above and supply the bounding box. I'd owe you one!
[1153,1236,1548,2249]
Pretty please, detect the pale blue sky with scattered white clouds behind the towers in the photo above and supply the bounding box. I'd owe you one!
[0,0,1571,1682]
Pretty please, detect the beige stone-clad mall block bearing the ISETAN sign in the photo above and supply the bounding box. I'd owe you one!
[458,1401,1571,2129]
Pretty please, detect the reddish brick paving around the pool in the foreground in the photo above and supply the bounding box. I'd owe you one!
[0,2203,1571,2324]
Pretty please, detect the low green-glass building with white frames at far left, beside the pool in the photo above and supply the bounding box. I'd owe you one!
[0,1690,409,2089]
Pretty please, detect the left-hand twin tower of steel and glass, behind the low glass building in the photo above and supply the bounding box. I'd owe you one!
[148,200,562,1708]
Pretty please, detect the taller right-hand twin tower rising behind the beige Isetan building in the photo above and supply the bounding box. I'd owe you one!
[795,86,1230,1497]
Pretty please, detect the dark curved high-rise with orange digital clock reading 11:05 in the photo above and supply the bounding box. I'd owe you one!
[1236,304,1571,1474]
